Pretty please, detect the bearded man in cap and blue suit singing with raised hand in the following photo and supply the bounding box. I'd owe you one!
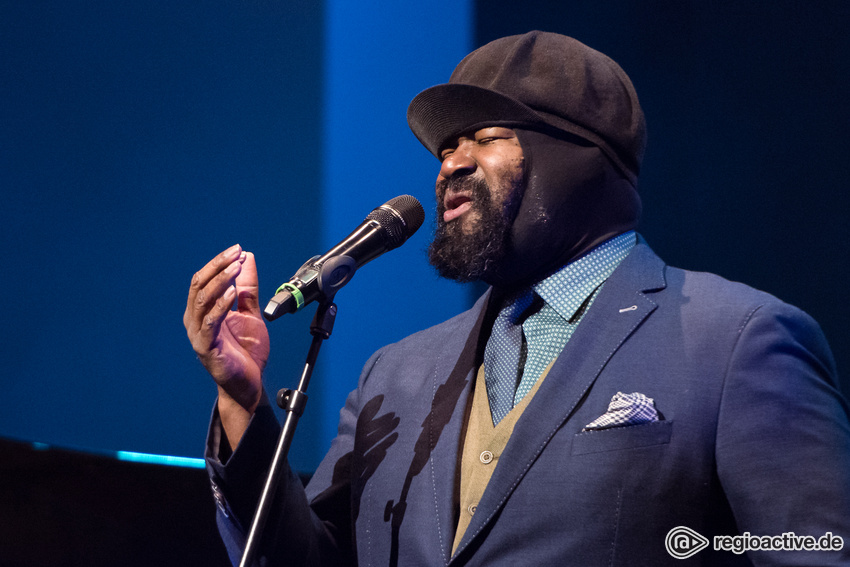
[184,32,850,567]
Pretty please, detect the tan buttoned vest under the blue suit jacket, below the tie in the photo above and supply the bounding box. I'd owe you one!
[452,361,554,554]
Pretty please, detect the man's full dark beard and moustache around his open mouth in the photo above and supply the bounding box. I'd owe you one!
[428,171,525,283]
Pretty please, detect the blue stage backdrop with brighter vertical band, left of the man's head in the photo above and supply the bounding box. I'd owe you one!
[0,0,472,470]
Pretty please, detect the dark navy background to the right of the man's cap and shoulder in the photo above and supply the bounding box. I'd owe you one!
[476,0,850,402]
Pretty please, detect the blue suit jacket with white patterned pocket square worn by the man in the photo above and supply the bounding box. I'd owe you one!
[208,241,850,567]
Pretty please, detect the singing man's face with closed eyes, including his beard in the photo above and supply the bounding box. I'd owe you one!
[428,127,525,281]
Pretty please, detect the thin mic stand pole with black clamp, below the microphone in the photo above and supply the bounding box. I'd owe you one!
[239,299,336,567]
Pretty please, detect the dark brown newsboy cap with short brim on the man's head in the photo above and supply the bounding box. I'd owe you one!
[407,31,646,184]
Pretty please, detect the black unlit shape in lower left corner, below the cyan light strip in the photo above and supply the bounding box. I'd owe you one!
[0,439,230,567]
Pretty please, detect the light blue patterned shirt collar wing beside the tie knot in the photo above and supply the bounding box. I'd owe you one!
[531,230,637,321]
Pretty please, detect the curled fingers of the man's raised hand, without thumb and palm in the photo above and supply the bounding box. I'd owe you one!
[183,244,246,337]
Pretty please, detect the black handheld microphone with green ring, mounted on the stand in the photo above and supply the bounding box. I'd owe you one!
[263,195,425,321]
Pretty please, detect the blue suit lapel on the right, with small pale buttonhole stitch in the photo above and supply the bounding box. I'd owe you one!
[456,239,665,555]
